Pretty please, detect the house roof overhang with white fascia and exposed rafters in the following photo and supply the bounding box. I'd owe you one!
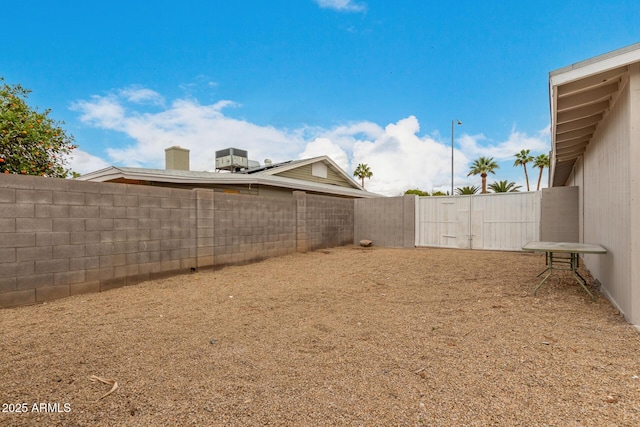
[549,43,640,187]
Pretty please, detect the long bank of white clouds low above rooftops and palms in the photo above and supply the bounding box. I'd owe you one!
[72,88,550,196]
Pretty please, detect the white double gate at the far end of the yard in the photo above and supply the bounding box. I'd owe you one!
[416,191,542,250]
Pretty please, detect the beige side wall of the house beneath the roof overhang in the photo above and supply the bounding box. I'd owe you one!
[567,64,640,325]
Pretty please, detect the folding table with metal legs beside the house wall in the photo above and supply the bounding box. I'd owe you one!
[522,242,607,301]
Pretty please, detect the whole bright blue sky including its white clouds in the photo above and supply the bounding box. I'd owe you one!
[0,0,640,195]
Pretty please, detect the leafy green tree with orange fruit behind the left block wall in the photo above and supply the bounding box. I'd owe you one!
[0,77,77,178]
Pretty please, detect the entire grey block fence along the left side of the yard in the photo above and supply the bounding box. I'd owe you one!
[0,175,354,307]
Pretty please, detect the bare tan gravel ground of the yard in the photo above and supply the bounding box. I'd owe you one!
[0,247,640,426]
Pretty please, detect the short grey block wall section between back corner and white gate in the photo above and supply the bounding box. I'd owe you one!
[354,195,417,248]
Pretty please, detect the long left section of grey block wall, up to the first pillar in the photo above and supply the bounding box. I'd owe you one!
[0,175,196,307]
